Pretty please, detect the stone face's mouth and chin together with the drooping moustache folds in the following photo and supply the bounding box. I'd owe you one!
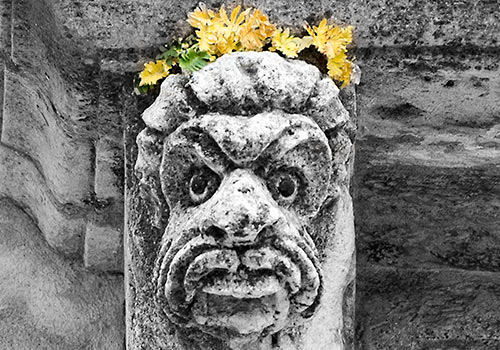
[159,237,320,341]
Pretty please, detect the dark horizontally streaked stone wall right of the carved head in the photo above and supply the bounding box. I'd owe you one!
[353,19,500,350]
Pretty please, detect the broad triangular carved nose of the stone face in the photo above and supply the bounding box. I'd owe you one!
[204,169,282,246]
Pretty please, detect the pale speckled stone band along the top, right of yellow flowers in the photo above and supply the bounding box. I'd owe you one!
[245,0,500,47]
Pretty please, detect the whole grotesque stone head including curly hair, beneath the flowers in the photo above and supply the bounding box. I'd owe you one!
[135,52,354,349]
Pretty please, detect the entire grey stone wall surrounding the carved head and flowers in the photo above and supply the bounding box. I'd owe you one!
[0,0,500,350]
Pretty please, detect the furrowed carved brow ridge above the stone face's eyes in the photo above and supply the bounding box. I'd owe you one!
[167,115,328,174]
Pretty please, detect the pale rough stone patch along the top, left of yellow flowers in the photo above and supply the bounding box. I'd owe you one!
[55,0,242,49]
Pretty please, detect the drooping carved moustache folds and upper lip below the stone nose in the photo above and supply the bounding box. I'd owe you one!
[157,230,320,320]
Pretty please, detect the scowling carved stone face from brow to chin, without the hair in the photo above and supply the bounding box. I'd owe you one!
[157,111,332,341]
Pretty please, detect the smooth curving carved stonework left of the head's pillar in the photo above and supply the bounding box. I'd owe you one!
[0,0,124,350]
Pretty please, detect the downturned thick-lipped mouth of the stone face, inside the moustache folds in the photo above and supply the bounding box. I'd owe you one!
[184,247,301,337]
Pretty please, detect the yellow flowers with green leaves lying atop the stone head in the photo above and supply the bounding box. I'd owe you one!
[135,4,353,93]
